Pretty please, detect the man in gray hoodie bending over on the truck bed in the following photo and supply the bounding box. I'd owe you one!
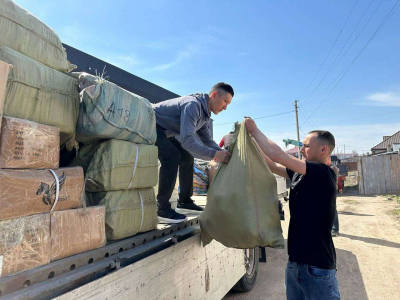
[154,82,234,223]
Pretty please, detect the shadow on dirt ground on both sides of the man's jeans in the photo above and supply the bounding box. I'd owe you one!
[224,241,368,300]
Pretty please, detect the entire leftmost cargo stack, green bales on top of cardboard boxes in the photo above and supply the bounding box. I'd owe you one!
[0,0,105,276]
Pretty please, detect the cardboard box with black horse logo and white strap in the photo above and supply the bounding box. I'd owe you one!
[0,167,84,220]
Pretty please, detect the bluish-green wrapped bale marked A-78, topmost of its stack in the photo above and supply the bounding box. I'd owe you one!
[76,78,157,145]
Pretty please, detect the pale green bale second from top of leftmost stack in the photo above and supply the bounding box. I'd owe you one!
[0,45,79,146]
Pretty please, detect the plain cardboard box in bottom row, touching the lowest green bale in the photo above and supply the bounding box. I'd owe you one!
[51,206,106,261]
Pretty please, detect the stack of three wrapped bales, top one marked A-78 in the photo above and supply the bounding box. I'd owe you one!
[72,73,158,240]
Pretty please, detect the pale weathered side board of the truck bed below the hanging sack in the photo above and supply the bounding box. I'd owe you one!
[56,234,245,300]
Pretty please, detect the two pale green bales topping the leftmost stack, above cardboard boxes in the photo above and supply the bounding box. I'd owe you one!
[0,0,79,150]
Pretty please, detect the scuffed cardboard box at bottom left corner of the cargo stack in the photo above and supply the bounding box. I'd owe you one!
[0,214,51,277]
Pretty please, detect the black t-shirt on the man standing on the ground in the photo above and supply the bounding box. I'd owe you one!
[286,161,337,269]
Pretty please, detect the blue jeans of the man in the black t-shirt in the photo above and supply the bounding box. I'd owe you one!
[285,261,340,300]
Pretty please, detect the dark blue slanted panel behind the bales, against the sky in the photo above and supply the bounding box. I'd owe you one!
[63,44,180,103]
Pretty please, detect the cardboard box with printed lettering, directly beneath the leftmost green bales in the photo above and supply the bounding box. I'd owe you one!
[0,117,60,169]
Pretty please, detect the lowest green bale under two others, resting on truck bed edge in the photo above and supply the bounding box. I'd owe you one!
[86,188,158,240]
